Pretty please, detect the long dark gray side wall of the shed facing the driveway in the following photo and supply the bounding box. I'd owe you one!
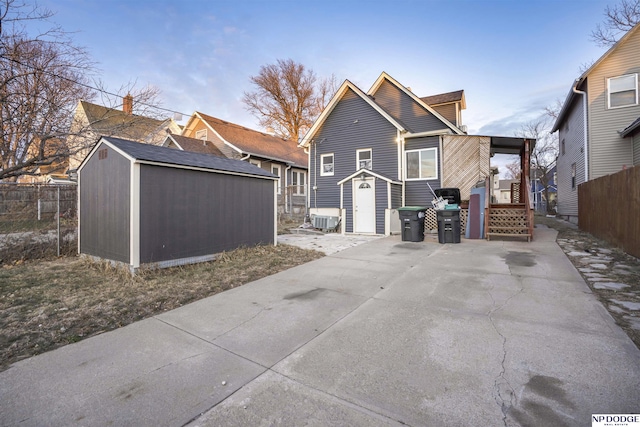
[140,165,274,263]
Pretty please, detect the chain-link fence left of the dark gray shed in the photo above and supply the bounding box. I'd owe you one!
[0,183,78,264]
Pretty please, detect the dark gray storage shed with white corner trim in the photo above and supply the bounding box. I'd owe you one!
[78,137,277,271]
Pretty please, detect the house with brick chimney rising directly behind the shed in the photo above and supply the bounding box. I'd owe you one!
[67,95,182,170]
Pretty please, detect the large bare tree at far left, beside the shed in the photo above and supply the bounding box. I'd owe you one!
[0,0,93,180]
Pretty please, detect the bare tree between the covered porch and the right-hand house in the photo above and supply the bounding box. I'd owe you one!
[516,116,558,213]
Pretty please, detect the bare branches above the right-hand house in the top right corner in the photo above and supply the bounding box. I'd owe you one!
[591,0,640,47]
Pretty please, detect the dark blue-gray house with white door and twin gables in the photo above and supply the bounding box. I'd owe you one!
[300,72,532,239]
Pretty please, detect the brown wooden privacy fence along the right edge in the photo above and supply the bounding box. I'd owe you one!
[578,166,640,258]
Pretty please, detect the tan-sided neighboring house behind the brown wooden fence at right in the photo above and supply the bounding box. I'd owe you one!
[552,24,640,222]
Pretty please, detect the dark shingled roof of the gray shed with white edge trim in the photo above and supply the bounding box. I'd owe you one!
[99,137,277,178]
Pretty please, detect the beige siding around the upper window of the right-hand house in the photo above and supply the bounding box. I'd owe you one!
[587,31,640,179]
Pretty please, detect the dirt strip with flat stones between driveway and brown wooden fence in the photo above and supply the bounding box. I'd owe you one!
[536,216,640,349]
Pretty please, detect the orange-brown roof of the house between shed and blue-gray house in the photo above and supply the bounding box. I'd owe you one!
[190,112,308,169]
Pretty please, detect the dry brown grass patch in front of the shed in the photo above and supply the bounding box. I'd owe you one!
[0,244,324,370]
